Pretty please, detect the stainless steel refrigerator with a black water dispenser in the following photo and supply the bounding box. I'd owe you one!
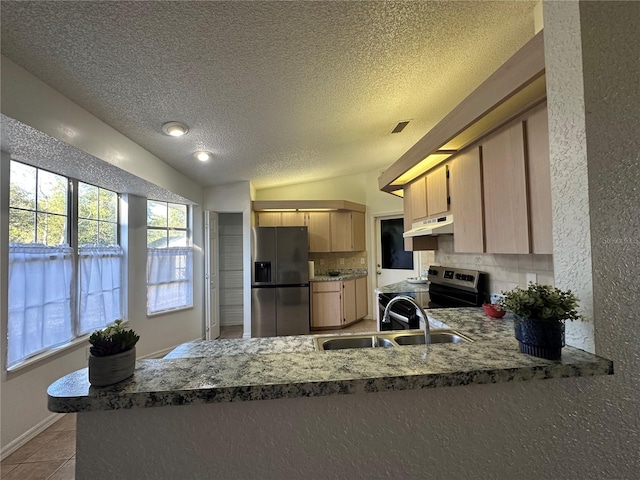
[251,227,310,337]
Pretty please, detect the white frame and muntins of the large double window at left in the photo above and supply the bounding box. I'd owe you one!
[2,159,127,373]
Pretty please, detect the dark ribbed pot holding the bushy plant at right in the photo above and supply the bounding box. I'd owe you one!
[514,315,564,360]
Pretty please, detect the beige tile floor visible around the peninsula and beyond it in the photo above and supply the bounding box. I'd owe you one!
[0,319,376,480]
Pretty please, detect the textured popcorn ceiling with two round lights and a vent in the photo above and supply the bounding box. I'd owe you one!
[0,0,535,189]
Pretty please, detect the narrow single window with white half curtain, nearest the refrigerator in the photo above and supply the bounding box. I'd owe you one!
[147,200,193,315]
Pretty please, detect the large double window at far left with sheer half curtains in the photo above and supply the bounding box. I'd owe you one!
[7,161,123,368]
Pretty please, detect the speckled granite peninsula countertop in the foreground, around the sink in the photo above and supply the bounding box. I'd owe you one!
[47,308,613,413]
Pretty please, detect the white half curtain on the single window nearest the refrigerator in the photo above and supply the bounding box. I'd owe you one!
[147,247,193,313]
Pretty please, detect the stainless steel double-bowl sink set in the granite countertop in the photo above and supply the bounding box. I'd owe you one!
[314,330,473,351]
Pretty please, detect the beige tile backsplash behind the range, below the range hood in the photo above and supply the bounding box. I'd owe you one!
[420,235,554,293]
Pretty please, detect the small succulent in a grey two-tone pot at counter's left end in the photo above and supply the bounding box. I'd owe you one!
[89,320,140,387]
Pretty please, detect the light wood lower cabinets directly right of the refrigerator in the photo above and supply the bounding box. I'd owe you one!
[311,277,367,329]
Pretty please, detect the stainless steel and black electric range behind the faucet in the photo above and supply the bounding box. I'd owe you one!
[378,266,487,330]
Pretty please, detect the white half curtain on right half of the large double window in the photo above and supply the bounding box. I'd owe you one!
[78,245,124,335]
